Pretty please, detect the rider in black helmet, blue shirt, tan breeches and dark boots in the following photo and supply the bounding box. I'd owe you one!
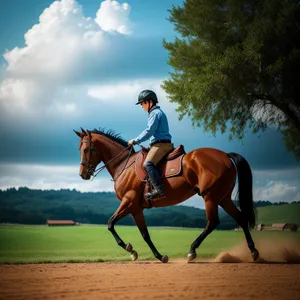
[128,90,173,199]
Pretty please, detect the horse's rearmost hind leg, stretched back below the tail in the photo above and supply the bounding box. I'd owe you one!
[220,193,259,261]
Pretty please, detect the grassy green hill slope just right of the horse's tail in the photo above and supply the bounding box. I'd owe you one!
[257,203,300,225]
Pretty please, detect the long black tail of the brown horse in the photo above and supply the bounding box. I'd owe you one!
[227,153,256,228]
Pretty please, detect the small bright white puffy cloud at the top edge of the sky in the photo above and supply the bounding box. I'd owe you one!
[95,0,131,34]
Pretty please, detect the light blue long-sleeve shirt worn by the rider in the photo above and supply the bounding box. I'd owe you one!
[134,105,172,144]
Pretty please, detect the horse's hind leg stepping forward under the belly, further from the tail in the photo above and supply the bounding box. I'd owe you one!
[188,196,220,262]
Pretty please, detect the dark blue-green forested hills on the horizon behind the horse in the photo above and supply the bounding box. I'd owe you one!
[0,187,298,229]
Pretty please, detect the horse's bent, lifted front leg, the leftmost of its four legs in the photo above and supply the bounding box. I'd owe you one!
[108,198,138,260]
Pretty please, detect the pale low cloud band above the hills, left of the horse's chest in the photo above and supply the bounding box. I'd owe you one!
[0,164,114,192]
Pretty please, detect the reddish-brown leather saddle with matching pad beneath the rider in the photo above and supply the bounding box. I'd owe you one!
[135,145,185,182]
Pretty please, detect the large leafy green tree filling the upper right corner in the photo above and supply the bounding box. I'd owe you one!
[163,0,300,159]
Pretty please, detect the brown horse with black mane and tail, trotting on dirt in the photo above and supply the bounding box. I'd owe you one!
[75,129,259,263]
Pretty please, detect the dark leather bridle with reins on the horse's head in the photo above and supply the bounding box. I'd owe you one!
[80,139,133,181]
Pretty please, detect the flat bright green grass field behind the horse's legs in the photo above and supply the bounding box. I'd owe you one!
[0,226,300,263]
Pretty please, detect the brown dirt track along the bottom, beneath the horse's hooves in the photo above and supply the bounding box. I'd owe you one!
[0,260,300,300]
